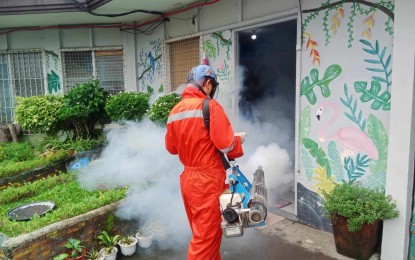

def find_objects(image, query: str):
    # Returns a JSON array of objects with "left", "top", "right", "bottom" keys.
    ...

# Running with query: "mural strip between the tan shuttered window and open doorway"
[{"left": 202, "top": 30, "right": 236, "bottom": 116}]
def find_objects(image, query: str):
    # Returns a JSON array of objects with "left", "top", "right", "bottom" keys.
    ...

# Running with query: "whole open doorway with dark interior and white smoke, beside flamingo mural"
[{"left": 237, "top": 20, "right": 297, "bottom": 214}]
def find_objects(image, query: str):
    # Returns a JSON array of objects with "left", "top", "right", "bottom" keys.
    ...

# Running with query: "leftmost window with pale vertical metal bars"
[{"left": 0, "top": 50, "right": 45, "bottom": 123}]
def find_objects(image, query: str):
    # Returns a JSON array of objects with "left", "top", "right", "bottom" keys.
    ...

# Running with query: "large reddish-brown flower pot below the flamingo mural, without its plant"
[{"left": 332, "top": 215, "right": 381, "bottom": 259}]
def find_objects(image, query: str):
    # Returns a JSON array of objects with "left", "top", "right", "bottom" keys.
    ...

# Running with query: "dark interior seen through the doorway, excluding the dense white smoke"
[{"left": 238, "top": 20, "right": 297, "bottom": 213}]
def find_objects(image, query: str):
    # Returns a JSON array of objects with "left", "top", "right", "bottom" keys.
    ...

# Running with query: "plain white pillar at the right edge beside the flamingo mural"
[{"left": 381, "top": 0, "right": 415, "bottom": 260}]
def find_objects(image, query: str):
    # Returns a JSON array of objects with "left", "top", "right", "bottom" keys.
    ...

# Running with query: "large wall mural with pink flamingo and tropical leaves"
[{"left": 297, "top": 0, "right": 394, "bottom": 231}]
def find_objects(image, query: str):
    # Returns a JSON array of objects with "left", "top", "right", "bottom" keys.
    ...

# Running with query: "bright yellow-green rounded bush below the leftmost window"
[{"left": 15, "top": 95, "right": 63, "bottom": 133}]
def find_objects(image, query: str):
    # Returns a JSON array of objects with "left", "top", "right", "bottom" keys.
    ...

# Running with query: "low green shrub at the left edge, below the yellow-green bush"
[{"left": 0, "top": 142, "right": 35, "bottom": 162}]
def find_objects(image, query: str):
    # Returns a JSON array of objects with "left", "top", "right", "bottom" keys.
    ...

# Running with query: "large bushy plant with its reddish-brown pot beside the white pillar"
[{"left": 323, "top": 183, "right": 399, "bottom": 259}]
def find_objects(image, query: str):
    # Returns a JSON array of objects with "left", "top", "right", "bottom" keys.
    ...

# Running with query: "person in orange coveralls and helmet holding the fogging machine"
[{"left": 165, "top": 65, "right": 246, "bottom": 260}]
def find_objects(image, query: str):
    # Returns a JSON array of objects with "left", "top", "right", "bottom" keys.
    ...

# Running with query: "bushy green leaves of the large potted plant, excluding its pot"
[{"left": 323, "top": 183, "right": 399, "bottom": 232}]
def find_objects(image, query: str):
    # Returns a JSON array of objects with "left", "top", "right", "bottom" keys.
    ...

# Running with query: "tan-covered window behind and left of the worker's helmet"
[{"left": 169, "top": 37, "right": 200, "bottom": 91}]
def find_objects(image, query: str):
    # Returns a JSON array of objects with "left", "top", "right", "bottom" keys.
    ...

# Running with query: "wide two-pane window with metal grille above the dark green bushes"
[{"left": 62, "top": 50, "right": 124, "bottom": 94}]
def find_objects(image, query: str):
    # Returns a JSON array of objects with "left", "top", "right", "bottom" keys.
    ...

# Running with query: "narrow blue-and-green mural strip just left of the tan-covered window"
[{"left": 137, "top": 37, "right": 164, "bottom": 94}]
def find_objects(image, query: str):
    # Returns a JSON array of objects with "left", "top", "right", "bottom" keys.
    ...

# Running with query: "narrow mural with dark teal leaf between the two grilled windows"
[{"left": 45, "top": 50, "right": 61, "bottom": 94}]
